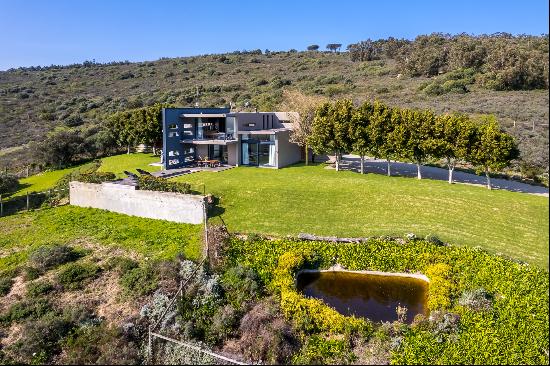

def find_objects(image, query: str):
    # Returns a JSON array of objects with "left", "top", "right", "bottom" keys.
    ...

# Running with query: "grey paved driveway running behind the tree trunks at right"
[{"left": 343, "top": 155, "right": 548, "bottom": 197}]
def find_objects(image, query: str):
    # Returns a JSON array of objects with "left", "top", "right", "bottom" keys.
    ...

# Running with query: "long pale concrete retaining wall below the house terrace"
[{"left": 69, "top": 182, "right": 205, "bottom": 224}]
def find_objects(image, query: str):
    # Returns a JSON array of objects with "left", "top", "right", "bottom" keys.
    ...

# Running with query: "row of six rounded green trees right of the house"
[{"left": 307, "top": 100, "right": 519, "bottom": 189}]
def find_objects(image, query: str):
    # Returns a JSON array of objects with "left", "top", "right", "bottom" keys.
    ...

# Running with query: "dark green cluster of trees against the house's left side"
[{"left": 108, "top": 103, "right": 170, "bottom": 154}]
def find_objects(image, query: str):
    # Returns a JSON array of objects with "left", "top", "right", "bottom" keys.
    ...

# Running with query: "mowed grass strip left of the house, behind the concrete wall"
[{"left": 9, "top": 153, "right": 160, "bottom": 196}]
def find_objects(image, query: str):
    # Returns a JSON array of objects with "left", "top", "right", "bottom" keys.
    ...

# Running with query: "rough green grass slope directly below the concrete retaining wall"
[{"left": 0, "top": 206, "right": 203, "bottom": 272}]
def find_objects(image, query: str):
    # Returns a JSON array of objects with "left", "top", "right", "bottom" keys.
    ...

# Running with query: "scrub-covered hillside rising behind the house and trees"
[{"left": 0, "top": 36, "right": 549, "bottom": 171}]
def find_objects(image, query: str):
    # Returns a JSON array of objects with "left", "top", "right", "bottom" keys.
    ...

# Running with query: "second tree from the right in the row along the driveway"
[{"left": 428, "top": 113, "right": 476, "bottom": 184}]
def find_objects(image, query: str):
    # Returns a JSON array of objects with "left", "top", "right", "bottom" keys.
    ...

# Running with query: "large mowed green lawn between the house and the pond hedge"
[{"left": 175, "top": 165, "right": 548, "bottom": 268}]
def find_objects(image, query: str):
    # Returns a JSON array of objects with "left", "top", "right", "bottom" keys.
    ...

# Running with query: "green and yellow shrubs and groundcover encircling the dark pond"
[{"left": 227, "top": 238, "right": 549, "bottom": 364}]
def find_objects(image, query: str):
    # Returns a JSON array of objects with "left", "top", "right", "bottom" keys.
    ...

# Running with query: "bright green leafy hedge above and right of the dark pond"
[{"left": 227, "top": 238, "right": 549, "bottom": 364}]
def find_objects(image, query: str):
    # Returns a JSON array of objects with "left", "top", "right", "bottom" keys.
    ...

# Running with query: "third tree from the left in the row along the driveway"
[{"left": 368, "top": 101, "right": 400, "bottom": 176}]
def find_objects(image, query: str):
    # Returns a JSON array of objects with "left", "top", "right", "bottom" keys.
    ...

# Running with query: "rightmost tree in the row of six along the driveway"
[{"left": 468, "top": 115, "right": 519, "bottom": 189}]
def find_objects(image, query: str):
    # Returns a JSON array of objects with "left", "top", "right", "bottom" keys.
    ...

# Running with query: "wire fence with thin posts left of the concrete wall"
[{"left": 0, "top": 188, "right": 69, "bottom": 217}]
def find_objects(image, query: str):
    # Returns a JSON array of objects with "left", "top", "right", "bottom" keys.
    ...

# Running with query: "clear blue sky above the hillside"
[{"left": 0, "top": 0, "right": 549, "bottom": 70}]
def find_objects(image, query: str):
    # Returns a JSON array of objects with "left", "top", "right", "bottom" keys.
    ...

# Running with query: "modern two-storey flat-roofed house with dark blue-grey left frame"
[{"left": 162, "top": 108, "right": 301, "bottom": 169}]
